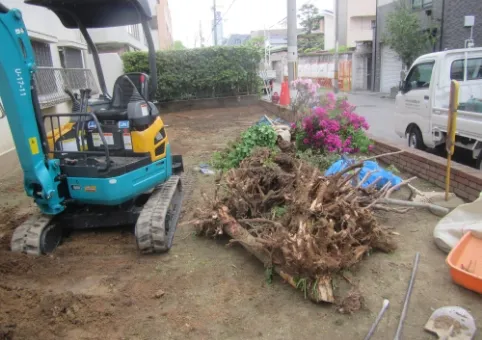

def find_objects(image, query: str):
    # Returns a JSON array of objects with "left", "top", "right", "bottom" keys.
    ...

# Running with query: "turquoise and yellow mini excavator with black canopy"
[{"left": 0, "top": 0, "right": 184, "bottom": 255}]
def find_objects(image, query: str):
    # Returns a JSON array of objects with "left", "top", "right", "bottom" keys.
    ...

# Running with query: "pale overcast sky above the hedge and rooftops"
[{"left": 169, "top": 0, "right": 333, "bottom": 47}]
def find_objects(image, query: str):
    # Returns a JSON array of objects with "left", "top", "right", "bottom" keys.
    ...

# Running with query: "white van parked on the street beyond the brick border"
[{"left": 394, "top": 48, "right": 482, "bottom": 169}]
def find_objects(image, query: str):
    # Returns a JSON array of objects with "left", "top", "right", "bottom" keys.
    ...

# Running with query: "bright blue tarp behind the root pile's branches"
[{"left": 325, "top": 156, "right": 402, "bottom": 189}]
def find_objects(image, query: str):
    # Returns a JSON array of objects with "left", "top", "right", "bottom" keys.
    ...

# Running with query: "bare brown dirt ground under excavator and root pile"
[{"left": 0, "top": 106, "right": 482, "bottom": 340}]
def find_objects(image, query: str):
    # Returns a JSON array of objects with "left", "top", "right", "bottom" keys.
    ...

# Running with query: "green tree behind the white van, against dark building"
[{"left": 383, "top": 1, "right": 434, "bottom": 68}]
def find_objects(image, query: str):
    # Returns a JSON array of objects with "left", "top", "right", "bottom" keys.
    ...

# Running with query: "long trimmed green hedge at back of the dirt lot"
[{"left": 122, "top": 46, "right": 261, "bottom": 102}]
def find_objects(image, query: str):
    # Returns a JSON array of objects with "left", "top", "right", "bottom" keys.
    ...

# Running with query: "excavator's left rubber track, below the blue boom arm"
[{"left": 10, "top": 213, "right": 62, "bottom": 255}]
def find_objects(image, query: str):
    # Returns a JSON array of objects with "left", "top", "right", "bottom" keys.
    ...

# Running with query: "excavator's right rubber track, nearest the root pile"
[{"left": 135, "top": 176, "right": 183, "bottom": 253}]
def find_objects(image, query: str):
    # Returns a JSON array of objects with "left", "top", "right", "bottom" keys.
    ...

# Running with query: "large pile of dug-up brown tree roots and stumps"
[{"left": 194, "top": 149, "right": 404, "bottom": 302}]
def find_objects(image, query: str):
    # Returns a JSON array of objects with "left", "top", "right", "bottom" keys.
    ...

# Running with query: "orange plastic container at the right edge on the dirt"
[{"left": 447, "top": 232, "right": 482, "bottom": 294}]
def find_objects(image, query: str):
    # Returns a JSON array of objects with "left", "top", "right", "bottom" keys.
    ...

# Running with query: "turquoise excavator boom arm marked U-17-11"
[{"left": 0, "top": 3, "right": 64, "bottom": 215}]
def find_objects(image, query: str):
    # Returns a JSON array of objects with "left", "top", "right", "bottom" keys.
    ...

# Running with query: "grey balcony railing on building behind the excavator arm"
[{"left": 35, "top": 67, "right": 99, "bottom": 109}]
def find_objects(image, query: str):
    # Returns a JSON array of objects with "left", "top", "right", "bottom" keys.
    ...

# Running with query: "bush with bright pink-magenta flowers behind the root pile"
[{"left": 292, "top": 93, "right": 371, "bottom": 154}]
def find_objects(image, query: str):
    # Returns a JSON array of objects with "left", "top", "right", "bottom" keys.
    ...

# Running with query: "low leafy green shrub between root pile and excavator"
[{"left": 211, "top": 125, "right": 278, "bottom": 170}]
